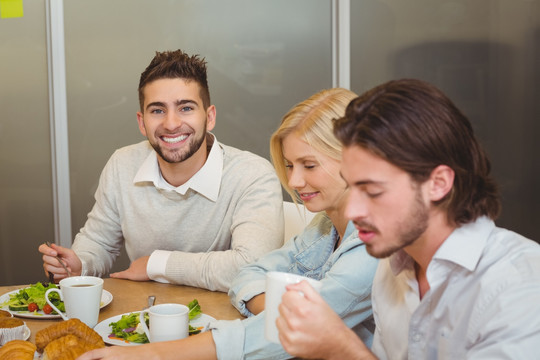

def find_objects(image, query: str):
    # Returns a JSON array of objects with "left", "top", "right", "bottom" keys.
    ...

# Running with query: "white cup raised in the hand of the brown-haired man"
[{"left": 264, "top": 271, "right": 322, "bottom": 344}]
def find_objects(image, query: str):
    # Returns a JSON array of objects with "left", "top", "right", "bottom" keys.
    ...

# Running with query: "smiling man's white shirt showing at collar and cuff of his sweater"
[{"left": 133, "top": 135, "right": 223, "bottom": 283}]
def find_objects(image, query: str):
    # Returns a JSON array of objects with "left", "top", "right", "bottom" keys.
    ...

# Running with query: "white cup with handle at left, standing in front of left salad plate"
[{"left": 45, "top": 276, "right": 103, "bottom": 328}]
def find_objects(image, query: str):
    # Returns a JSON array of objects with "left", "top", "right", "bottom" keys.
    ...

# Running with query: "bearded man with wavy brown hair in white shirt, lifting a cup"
[{"left": 277, "top": 79, "right": 540, "bottom": 359}]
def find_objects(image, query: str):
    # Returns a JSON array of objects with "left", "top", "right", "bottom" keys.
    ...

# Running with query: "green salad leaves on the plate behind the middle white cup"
[{"left": 109, "top": 299, "right": 202, "bottom": 344}]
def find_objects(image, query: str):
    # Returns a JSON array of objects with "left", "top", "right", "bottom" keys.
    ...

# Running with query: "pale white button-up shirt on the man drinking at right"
[{"left": 372, "top": 217, "right": 540, "bottom": 360}]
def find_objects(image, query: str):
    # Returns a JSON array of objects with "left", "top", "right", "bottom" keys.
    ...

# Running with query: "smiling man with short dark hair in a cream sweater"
[{"left": 39, "top": 50, "right": 283, "bottom": 291}]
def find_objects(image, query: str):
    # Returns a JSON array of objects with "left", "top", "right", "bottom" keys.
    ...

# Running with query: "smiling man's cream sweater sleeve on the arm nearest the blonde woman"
[{"left": 165, "top": 155, "right": 283, "bottom": 292}]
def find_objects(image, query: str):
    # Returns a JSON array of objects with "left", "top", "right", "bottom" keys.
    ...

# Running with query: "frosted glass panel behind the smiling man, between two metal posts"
[{"left": 64, "top": 0, "right": 332, "bottom": 267}]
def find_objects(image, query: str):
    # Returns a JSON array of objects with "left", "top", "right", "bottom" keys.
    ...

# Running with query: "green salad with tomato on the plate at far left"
[{"left": 0, "top": 282, "right": 65, "bottom": 314}]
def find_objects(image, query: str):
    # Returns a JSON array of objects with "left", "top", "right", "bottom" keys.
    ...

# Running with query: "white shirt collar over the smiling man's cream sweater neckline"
[{"left": 133, "top": 133, "right": 223, "bottom": 202}]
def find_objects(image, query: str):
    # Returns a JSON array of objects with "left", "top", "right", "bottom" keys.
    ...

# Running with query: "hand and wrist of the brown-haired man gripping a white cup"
[{"left": 276, "top": 281, "right": 375, "bottom": 359}]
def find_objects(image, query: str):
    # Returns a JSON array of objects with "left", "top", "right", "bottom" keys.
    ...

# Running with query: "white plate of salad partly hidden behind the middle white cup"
[{"left": 94, "top": 299, "right": 215, "bottom": 346}]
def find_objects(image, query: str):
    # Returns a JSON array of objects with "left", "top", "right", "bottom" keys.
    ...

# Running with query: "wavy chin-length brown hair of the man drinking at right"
[{"left": 334, "top": 79, "right": 501, "bottom": 225}]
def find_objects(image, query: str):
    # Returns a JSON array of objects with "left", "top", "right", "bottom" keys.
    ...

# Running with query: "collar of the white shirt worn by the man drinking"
[{"left": 390, "top": 216, "right": 495, "bottom": 275}]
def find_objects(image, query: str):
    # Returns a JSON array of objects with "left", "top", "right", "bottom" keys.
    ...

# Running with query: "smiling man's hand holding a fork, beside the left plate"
[{"left": 38, "top": 244, "right": 82, "bottom": 282}]
